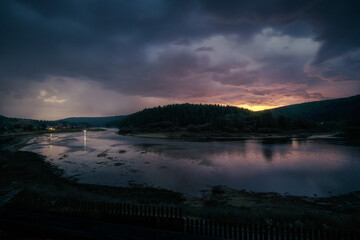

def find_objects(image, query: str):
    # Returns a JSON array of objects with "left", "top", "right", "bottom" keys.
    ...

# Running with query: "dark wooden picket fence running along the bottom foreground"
[{"left": 12, "top": 199, "right": 360, "bottom": 240}]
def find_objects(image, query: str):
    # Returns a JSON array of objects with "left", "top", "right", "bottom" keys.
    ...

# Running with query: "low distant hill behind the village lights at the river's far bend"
[{"left": 62, "top": 116, "right": 125, "bottom": 127}]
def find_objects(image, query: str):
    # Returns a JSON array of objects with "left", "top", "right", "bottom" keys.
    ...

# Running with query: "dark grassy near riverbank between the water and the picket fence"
[{"left": 0, "top": 131, "right": 360, "bottom": 231}]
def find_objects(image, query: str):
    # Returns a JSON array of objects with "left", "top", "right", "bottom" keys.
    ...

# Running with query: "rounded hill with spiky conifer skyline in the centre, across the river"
[{"left": 119, "top": 103, "right": 315, "bottom": 133}]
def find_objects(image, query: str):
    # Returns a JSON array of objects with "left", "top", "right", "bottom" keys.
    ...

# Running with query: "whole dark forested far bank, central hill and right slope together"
[{"left": 119, "top": 95, "right": 360, "bottom": 137}]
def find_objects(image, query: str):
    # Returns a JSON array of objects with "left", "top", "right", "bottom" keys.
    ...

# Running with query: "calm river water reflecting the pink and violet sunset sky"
[{"left": 22, "top": 130, "right": 360, "bottom": 196}]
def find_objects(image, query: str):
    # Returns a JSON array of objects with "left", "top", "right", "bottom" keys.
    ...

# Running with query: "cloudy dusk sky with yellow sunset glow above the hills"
[{"left": 0, "top": 0, "right": 360, "bottom": 120}]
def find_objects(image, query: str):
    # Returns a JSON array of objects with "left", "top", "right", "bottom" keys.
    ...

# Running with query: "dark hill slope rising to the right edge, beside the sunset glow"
[{"left": 271, "top": 95, "right": 360, "bottom": 122}]
